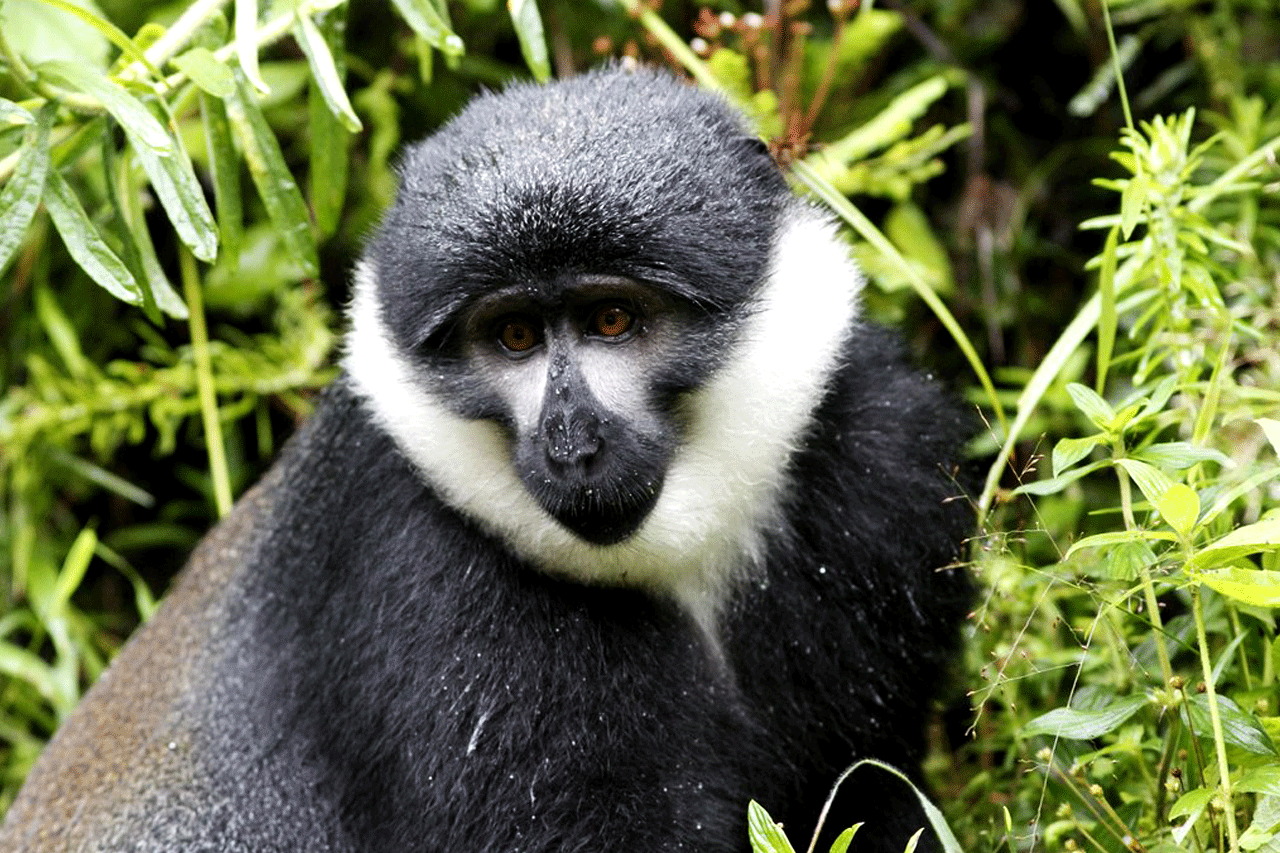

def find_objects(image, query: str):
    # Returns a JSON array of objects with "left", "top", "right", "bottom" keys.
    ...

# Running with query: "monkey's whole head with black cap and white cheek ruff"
[{"left": 346, "top": 70, "right": 859, "bottom": 604}]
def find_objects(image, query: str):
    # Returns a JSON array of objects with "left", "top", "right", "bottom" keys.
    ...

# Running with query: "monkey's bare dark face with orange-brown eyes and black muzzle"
[{"left": 439, "top": 275, "right": 705, "bottom": 544}]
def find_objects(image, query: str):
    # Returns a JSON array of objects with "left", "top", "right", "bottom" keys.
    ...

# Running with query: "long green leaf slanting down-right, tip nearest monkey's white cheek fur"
[{"left": 227, "top": 73, "right": 319, "bottom": 275}]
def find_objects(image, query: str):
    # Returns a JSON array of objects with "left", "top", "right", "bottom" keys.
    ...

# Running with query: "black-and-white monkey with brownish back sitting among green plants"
[{"left": 0, "top": 68, "right": 973, "bottom": 853}]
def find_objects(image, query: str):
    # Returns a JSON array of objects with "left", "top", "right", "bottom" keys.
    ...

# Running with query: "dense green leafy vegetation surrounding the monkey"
[{"left": 0, "top": 0, "right": 1280, "bottom": 853}]
